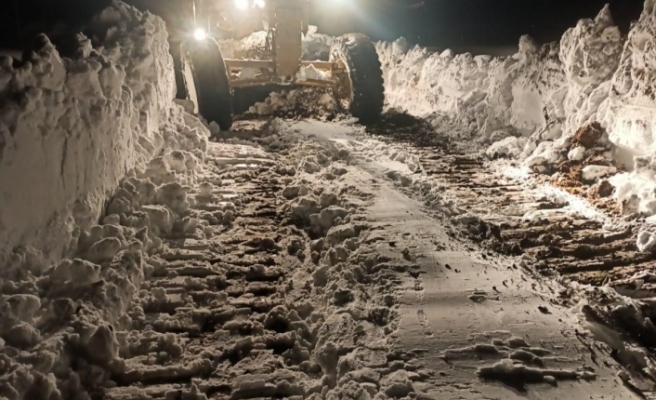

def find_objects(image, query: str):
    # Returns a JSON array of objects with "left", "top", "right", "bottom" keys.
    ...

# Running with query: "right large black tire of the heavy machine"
[{"left": 330, "top": 33, "right": 385, "bottom": 124}]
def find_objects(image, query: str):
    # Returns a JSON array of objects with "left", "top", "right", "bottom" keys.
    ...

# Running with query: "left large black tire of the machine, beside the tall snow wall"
[{"left": 188, "top": 38, "right": 232, "bottom": 131}]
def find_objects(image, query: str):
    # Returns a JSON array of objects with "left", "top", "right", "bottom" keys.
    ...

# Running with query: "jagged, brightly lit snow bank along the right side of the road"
[{"left": 377, "top": 0, "right": 656, "bottom": 225}]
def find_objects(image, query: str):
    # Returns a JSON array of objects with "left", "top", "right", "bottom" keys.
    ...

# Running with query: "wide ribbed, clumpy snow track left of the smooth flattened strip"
[{"left": 99, "top": 125, "right": 426, "bottom": 399}]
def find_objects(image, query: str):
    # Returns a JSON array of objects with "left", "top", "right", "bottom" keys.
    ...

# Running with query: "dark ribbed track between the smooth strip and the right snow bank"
[{"left": 356, "top": 113, "right": 656, "bottom": 394}]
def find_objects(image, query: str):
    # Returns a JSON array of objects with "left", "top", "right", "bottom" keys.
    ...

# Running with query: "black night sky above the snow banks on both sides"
[{"left": 0, "top": 0, "right": 644, "bottom": 50}]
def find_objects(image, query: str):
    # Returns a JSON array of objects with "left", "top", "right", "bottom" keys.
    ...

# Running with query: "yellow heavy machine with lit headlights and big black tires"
[{"left": 165, "top": 0, "right": 384, "bottom": 130}]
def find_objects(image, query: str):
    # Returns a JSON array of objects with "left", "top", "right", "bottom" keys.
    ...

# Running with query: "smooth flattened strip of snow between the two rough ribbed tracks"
[{"left": 250, "top": 121, "right": 638, "bottom": 399}]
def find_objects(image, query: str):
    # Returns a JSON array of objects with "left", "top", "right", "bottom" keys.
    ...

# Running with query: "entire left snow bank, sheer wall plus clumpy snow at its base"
[{"left": 0, "top": 2, "right": 214, "bottom": 400}]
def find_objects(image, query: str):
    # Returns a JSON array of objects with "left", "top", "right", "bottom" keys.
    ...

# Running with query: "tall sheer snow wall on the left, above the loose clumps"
[{"left": 0, "top": 2, "right": 175, "bottom": 272}]
